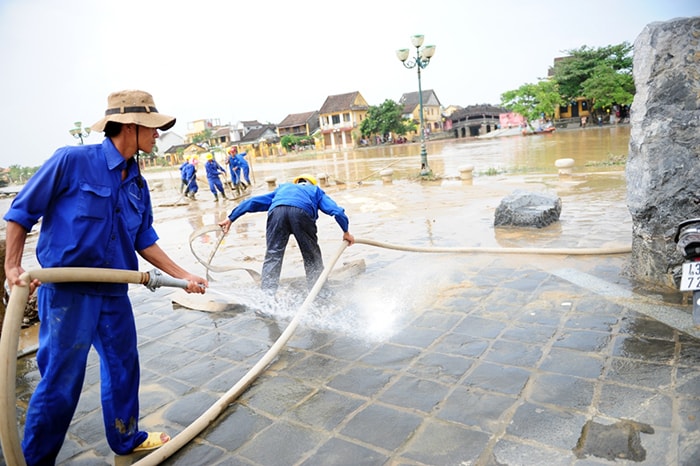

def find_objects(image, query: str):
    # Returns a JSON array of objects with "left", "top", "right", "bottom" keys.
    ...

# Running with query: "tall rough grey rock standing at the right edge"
[{"left": 626, "top": 17, "right": 700, "bottom": 288}]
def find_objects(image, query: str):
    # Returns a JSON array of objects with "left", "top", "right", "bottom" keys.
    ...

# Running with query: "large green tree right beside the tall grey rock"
[{"left": 552, "top": 42, "right": 635, "bottom": 109}]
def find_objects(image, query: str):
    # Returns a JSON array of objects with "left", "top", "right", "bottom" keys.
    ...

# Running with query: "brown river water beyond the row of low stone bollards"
[{"left": 223, "top": 126, "right": 629, "bottom": 183}]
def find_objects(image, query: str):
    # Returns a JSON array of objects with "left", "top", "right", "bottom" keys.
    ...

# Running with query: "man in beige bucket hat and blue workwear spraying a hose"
[{"left": 4, "top": 91, "right": 208, "bottom": 466}]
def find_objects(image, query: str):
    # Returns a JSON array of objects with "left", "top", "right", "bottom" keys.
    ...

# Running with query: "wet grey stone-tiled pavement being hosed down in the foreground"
[{"left": 1, "top": 173, "right": 700, "bottom": 466}]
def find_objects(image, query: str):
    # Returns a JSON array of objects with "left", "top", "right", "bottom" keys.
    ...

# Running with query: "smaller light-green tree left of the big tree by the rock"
[{"left": 501, "top": 79, "right": 563, "bottom": 127}]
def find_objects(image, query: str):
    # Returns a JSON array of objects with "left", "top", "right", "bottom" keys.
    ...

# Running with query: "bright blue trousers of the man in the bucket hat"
[{"left": 22, "top": 286, "right": 148, "bottom": 466}]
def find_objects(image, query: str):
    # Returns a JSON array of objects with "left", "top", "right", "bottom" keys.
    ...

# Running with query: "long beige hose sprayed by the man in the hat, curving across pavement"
[{"left": 0, "top": 238, "right": 631, "bottom": 466}]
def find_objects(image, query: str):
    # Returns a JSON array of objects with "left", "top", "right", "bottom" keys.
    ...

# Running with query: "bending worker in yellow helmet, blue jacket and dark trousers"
[{"left": 219, "top": 174, "right": 355, "bottom": 294}]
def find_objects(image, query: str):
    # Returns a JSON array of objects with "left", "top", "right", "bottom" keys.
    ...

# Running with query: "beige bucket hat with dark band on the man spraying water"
[{"left": 90, "top": 90, "right": 175, "bottom": 131}]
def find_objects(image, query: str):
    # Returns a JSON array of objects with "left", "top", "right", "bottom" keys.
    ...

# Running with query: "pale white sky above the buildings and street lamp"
[{"left": 0, "top": 0, "right": 700, "bottom": 167}]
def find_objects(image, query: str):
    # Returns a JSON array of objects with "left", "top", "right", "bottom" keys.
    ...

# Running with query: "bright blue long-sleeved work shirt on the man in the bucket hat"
[{"left": 4, "top": 138, "right": 158, "bottom": 296}]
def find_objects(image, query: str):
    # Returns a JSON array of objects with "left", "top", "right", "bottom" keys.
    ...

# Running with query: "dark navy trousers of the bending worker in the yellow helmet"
[{"left": 262, "top": 205, "right": 323, "bottom": 293}]
